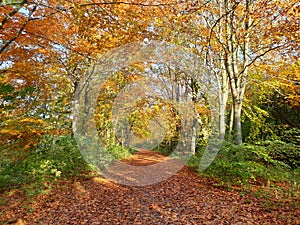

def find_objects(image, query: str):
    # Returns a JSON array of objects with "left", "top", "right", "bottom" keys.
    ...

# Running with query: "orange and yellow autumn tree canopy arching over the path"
[{"left": 0, "top": 0, "right": 300, "bottom": 149}]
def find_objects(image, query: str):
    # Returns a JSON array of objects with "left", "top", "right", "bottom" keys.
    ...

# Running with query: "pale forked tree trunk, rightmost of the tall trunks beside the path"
[{"left": 224, "top": 0, "right": 251, "bottom": 144}]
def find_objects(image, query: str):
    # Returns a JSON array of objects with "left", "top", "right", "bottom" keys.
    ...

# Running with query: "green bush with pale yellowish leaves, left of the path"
[{"left": 0, "top": 135, "right": 89, "bottom": 189}]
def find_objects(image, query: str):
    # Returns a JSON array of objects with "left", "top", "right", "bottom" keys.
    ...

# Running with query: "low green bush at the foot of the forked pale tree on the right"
[{"left": 188, "top": 142, "right": 293, "bottom": 184}]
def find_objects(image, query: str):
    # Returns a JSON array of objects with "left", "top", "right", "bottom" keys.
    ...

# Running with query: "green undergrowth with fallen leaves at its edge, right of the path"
[{"left": 188, "top": 141, "right": 300, "bottom": 209}]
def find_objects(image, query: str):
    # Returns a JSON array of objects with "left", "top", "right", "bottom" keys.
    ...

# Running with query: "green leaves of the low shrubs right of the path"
[{"left": 193, "top": 142, "right": 300, "bottom": 185}]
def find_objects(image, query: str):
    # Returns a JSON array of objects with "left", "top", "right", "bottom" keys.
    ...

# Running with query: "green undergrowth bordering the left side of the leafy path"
[{"left": 0, "top": 135, "right": 134, "bottom": 195}]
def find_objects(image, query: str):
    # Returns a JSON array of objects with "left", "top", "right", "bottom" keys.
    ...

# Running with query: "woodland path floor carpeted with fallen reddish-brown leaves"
[{"left": 0, "top": 151, "right": 300, "bottom": 225}]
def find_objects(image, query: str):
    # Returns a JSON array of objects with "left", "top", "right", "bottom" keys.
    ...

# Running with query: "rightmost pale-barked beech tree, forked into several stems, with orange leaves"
[{"left": 212, "top": 0, "right": 299, "bottom": 144}]
